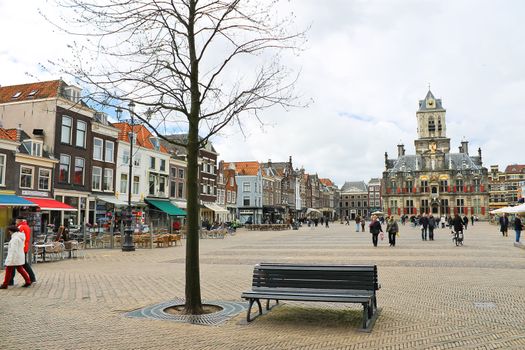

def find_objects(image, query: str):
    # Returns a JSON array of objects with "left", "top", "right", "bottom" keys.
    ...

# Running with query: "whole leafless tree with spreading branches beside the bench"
[{"left": 51, "top": 0, "right": 304, "bottom": 314}]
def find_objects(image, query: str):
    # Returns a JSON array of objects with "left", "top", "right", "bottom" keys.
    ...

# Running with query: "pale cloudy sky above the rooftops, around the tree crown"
[{"left": 0, "top": 0, "right": 525, "bottom": 186}]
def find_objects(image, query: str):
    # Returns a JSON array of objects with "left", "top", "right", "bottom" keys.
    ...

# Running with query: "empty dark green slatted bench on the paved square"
[{"left": 241, "top": 263, "right": 381, "bottom": 330}]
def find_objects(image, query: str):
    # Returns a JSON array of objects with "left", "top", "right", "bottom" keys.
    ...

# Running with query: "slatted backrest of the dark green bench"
[{"left": 252, "top": 263, "right": 379, "bottom": 291}]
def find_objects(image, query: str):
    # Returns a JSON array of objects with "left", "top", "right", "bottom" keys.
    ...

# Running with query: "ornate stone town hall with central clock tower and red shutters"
[{"left": 381, "top": 90, "right": 488, "bottom": 218}]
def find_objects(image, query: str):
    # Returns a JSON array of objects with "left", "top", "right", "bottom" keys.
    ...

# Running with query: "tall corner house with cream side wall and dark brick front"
[{"left": 0, "top": 80, "right": 94, "bottom": 225}]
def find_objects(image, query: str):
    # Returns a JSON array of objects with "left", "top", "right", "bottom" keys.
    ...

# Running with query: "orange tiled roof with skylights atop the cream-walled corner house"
[{"left": 0, "top": 80, "right": 63, "bottom": 103}]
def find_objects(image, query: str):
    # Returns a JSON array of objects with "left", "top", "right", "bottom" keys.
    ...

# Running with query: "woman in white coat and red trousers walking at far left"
[{"left": 0, "top": 225, "right": 31, "bottom": 289}]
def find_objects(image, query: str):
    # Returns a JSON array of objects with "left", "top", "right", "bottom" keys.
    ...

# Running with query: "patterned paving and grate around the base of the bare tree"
[{"left": 125, "top": 299, "right": 248, "bottom": 326}]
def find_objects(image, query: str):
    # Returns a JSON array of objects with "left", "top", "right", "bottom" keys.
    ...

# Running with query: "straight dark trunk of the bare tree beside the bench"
[{"left": 185, "top": 0, "right": 203, "bottom": 315}]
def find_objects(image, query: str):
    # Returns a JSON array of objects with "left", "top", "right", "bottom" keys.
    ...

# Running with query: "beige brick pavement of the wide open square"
[{"left": 0, "top": 223, "right": 525, "bottom": 349}]
